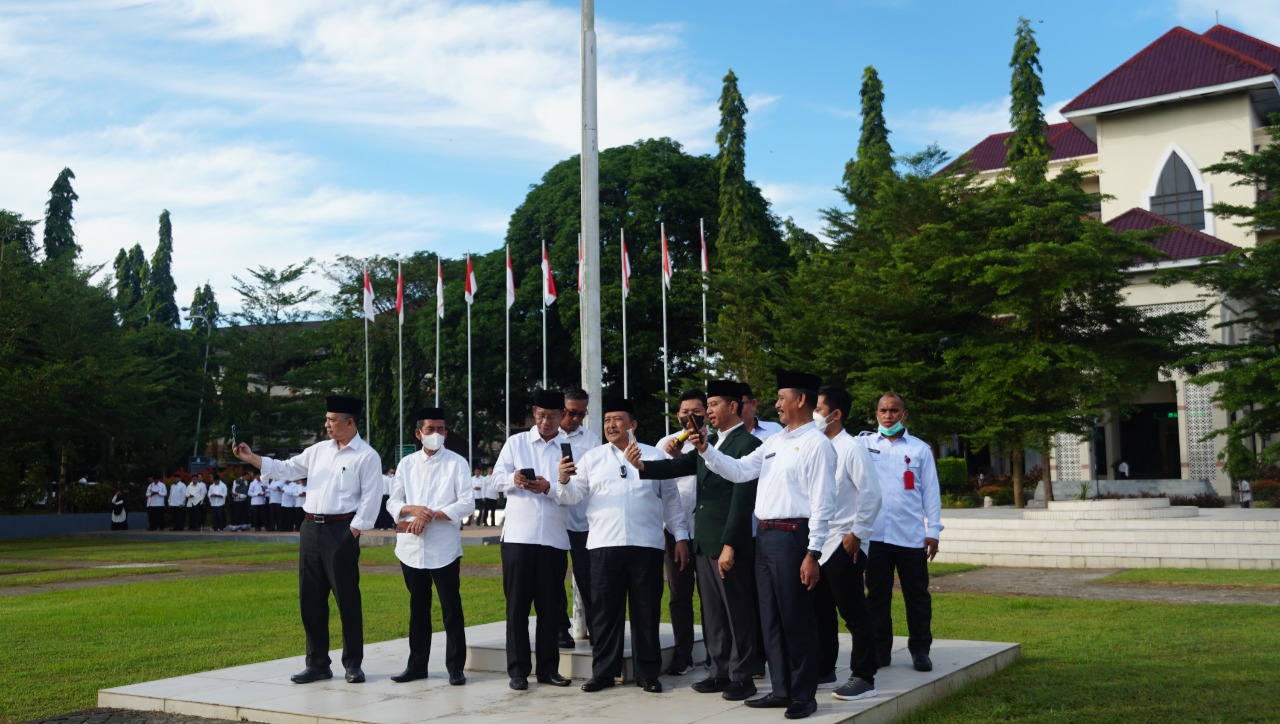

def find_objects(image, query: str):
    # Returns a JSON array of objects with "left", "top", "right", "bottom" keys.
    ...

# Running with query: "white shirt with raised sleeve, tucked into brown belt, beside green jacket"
[{"left": 703, "top": 422, "right": 836, "bottom": 550}]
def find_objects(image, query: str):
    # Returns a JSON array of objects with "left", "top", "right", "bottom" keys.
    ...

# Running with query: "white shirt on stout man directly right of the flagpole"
[{"left": 553, "top": 444, "right": 689, "bottom": 550}]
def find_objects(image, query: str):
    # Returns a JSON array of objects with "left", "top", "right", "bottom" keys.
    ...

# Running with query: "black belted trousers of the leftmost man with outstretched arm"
[{"left": 298, "top": 521, "right": 365, "bottom": 669}]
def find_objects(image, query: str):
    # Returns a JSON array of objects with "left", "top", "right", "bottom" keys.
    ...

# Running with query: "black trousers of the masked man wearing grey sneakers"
[{"left": 813, "top": 545, "right": 877, "bottom": 684}]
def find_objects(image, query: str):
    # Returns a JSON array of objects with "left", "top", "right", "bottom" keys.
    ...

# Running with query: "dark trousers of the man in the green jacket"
[{"left": 694, "top": 555, "right": 759, "bottom": 682}]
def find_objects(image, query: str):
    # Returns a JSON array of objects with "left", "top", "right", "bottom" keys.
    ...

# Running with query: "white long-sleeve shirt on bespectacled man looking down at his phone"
[{"left": 489, "top": 427, "right": 568, "bottom": 550}]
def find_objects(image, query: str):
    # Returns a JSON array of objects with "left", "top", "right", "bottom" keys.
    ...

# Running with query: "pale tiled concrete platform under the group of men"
[{"left": 97, "top": 622, "right": 1020, "bottom": 724}]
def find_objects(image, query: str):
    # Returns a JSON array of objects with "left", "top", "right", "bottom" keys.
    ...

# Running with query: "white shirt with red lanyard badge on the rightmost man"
[{"left": 856, "top": 432, "right": 942, "bottom": 547}]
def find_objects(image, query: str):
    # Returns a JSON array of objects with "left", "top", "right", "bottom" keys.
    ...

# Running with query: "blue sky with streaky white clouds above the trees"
[{"left": 0, "top": 0, "right": 1280, "bottom": 317}]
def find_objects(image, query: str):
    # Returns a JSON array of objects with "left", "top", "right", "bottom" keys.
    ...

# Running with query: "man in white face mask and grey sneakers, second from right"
[{"left": 813, "top": 386, "right": 881, "bottom": 701}]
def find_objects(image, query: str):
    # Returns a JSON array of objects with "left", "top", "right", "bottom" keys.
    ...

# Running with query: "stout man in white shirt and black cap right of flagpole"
[{"left": 556, "top": 398, "right": 689, "bottom": 693}]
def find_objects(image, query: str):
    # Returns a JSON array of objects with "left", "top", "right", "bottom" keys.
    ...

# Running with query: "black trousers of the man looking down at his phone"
[{"left": 502, "top": 542, "right": 567, "bottom": 677}]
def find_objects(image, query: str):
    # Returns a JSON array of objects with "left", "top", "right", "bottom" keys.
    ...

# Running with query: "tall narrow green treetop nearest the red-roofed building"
[{"left": 1005, "top": 18, "right": 1050, "bottom": 180}]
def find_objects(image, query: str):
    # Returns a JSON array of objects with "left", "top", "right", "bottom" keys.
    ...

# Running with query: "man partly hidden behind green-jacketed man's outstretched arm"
[{"left": 654, "top": 390, "right": 707, "bottom": 677}]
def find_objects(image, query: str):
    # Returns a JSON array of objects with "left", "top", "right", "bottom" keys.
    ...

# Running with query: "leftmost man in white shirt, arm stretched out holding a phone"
[{"left": 236, "top": 397, "right": 383, "bottom": 684}]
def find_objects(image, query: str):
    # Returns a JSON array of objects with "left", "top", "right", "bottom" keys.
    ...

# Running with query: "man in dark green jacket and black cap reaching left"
[{"left": 627, "top": 380, "right": 760, "bottom": 701}]
